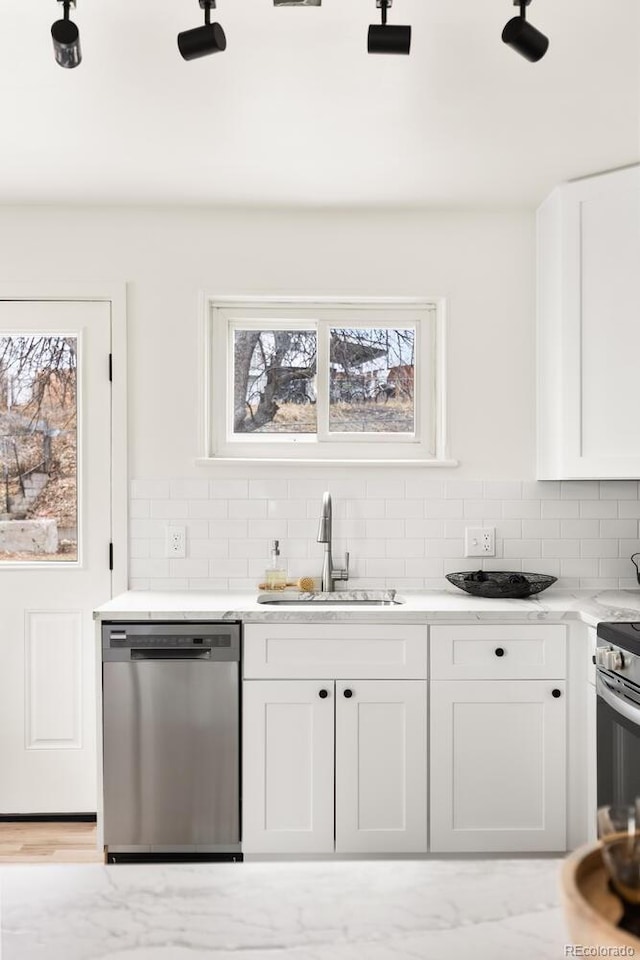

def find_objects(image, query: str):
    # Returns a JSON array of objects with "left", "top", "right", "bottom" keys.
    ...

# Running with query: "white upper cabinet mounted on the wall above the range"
[{"left": 537, "top": 166, "right": 640, "bottom": 480}]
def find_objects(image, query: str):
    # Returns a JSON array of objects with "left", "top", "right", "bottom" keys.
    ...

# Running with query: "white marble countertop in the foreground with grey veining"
[{"left": 0, "top": 859, "right": 570, "bottom": 960}]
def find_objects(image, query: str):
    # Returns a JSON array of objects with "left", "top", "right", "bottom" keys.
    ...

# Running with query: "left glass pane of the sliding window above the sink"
[{"left": 233, "top": 330, "right": 317, "bottom": 435}]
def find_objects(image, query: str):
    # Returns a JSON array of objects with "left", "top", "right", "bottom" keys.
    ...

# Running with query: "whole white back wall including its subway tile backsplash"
[{"left": 0, "top": 205, "right": 640, "bottom": 589}]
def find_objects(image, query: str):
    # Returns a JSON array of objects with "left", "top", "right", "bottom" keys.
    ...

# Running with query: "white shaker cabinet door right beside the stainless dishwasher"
[{"left": 242, "top": 680, "right": 334, "bottom": 853}]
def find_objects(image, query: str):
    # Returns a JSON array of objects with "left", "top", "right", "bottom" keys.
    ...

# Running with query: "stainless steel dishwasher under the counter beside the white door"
[{"left": 102, "top": 622, "right": 242, "bottom": 863}]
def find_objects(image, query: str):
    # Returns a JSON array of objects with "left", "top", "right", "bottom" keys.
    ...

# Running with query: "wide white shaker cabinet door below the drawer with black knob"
[{"left": 430, "top": 680, "right": 566, "bottom": 853}]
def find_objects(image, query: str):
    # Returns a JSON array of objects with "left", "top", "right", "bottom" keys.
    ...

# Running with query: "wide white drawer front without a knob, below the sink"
[{"left": 244, "top": 623, "right": 427, "bottom": 680}]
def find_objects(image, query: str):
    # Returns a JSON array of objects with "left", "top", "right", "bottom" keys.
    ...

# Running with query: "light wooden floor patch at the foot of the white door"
[{"left": 0, "top": 821, "right": 104, "bottom": 864}]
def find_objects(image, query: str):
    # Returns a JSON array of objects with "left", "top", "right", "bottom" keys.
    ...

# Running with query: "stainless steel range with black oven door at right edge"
[{"left": 595, "top": 623, "right": 640, "bottom": 806}]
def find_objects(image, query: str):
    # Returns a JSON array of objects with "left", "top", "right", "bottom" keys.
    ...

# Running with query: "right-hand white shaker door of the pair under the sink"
[{"left": 336, "top": 680, "right": 427, "bottom": 853}]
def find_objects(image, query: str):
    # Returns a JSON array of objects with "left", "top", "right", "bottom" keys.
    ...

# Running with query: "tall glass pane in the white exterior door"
[{"left": 0, "top": 336, "right": 78, "bottom": 563}]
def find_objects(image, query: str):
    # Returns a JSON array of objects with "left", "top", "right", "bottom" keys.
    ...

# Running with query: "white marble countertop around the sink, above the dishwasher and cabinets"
[{"left": 94, "top": 587, "right": 640, "bottom": 626}]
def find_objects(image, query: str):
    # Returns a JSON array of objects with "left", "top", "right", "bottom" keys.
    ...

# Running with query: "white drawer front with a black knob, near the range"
[{"left": 430, "top": 624, "right": 566, "bottom": 680}]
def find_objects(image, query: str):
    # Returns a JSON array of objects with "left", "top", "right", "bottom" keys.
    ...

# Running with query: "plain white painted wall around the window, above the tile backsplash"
[{"left": 0, "top": 207, "right": 535, "bottom": 480}]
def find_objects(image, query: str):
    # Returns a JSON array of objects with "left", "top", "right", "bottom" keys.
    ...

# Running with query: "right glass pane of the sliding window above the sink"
[{"left": 329, "top": 327, "right": 415, "bottom": 433}]
